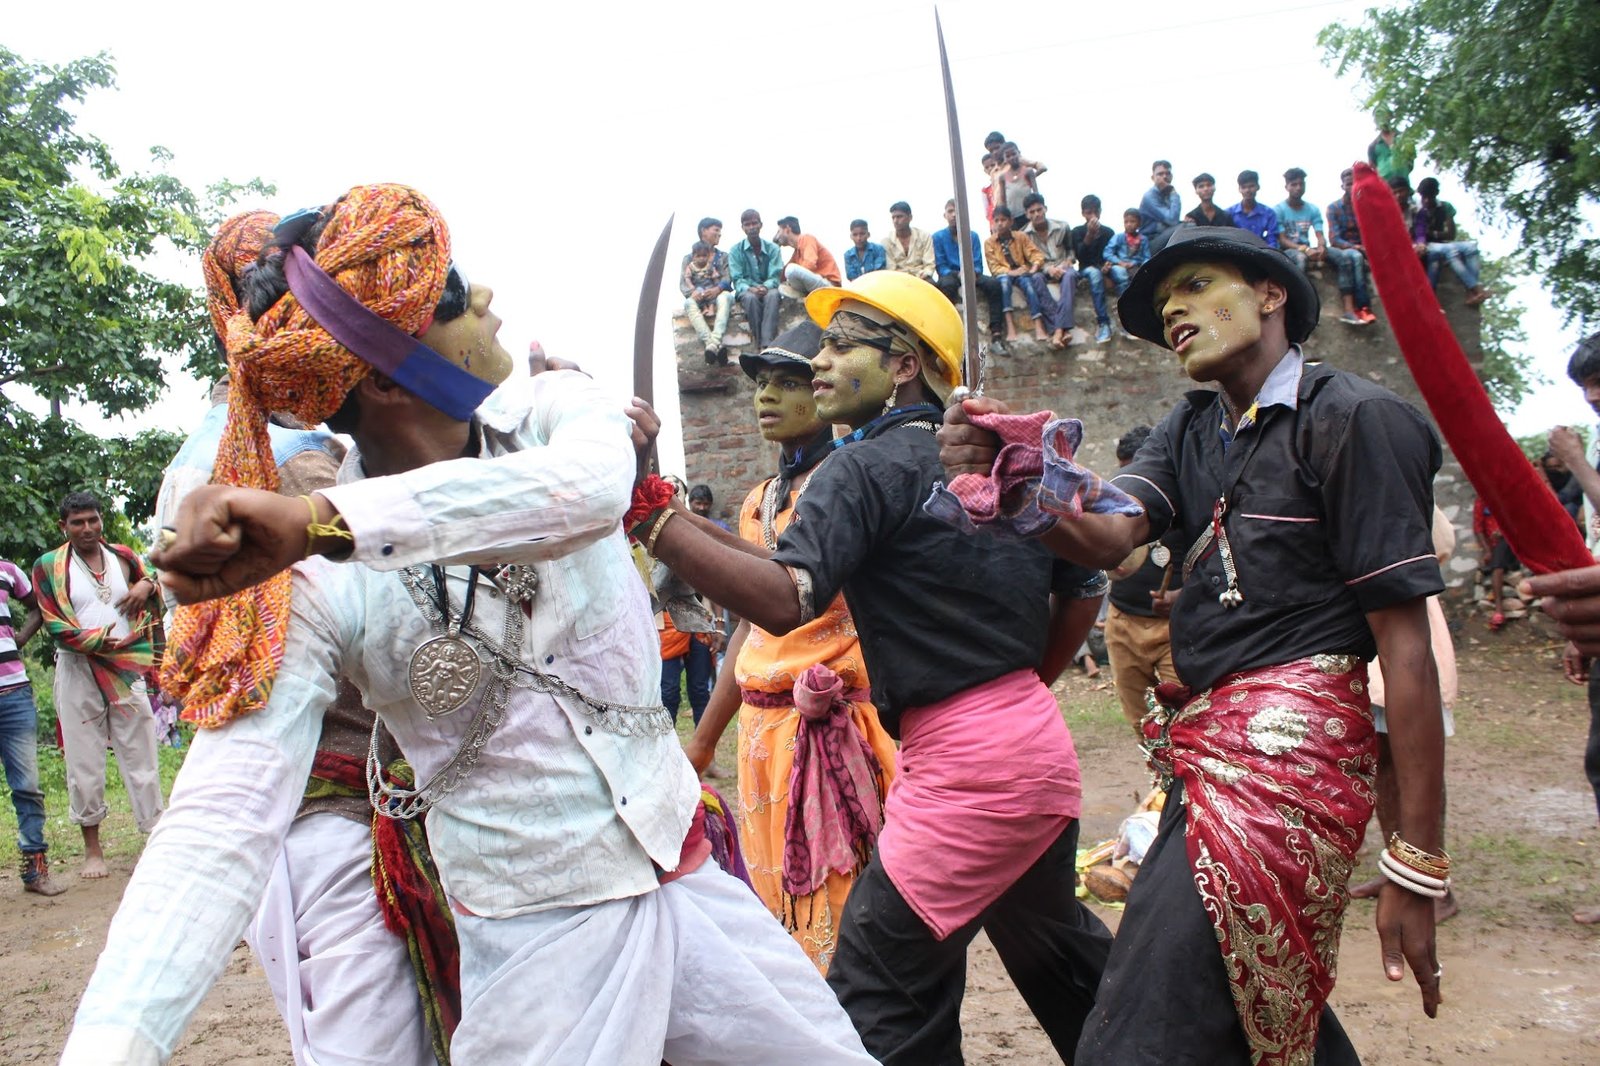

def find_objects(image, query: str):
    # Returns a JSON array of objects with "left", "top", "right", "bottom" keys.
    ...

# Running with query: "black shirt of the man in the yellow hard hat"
[{"left": 773, "top": 408, "right": 1106, "bottom": 736}]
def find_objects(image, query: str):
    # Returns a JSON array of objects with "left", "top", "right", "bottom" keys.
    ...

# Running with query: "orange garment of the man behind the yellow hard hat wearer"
[{"left": 734, "top": 482, "right": 896, "bottom": 975}]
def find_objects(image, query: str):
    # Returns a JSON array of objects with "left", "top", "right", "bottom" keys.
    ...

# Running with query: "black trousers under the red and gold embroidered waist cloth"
[{"left": 1078, "top": 784, "right": 1362, "bottom": 1066}]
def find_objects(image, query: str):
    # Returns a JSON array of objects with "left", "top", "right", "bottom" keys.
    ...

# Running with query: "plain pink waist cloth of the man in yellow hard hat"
[{"left": 878, "top": 671, "right": 1082, "bottom": 940}]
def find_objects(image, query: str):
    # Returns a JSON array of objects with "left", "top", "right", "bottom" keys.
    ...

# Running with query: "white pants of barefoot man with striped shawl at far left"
[{"left": 54, "top": 651, "right": 162, "bottom": 832}]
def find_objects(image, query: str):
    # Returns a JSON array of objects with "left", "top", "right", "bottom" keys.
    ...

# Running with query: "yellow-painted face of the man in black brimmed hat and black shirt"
[{"left": 1155, "top": 261, "right": 1262, "bottom": 381}]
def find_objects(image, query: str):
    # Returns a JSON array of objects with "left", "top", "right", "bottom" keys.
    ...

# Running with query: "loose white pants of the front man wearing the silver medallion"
[{"left": 450, "top": 861, "right": 874, "bottom": 1066}]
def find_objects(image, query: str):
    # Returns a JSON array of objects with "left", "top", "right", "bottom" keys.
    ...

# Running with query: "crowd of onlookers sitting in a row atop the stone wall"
[{"left": 680, "top": 130, "right": 1490, "bottom": 363}]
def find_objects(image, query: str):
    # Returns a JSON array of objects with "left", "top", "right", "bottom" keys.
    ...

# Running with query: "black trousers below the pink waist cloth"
[{"left": 827, "top": 821, "right": 1113, "bottom": 1066}]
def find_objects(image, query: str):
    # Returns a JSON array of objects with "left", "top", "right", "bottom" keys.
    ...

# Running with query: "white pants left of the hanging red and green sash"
[{"left": 245, "top": 813, "right": 435, "bottom": 1066}]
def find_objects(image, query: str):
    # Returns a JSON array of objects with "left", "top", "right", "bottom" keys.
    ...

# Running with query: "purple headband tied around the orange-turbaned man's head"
[{"left": 283, "top": 245, "right": 494, "bottom": 423}]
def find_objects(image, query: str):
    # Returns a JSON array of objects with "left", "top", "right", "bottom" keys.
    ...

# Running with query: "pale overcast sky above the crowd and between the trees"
[{"left": 3, "top": 0, "right": 1594, "bottom": 469}]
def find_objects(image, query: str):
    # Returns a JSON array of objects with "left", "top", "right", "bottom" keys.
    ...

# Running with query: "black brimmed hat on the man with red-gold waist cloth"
[{"left": 1117, "top": 226, "right": 1322, "bottom": 347}]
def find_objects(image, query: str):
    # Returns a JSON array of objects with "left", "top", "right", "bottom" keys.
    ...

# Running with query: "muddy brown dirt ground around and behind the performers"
[{"left": 0, "top": 619, "right": 1600, "bottom": 1066}]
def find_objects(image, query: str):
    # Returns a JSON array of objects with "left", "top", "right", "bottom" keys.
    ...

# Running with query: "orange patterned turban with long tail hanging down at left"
[{"left": 162, "top": 184, "right": 450, "bottom": 728}]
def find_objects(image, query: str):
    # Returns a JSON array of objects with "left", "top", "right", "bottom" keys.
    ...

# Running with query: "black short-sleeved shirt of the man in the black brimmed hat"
[{"left": 1112, "top": 356, "right": 1445, "bottom": 691}]
